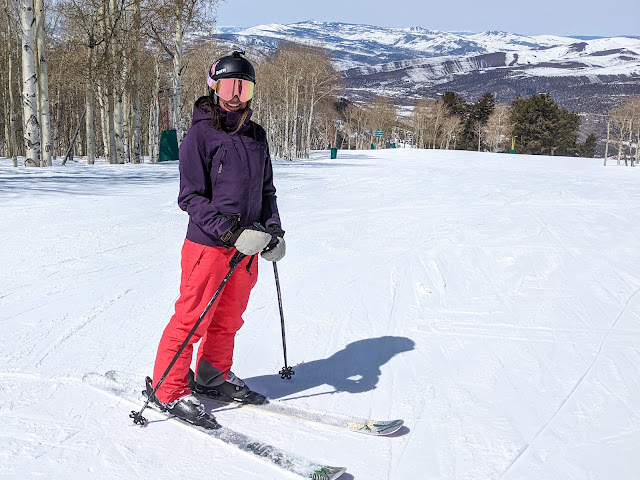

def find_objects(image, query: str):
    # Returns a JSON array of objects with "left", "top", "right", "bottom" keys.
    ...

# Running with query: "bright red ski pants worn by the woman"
[{"left": 153, "top": 240, "right": 258, "bottom": 403}]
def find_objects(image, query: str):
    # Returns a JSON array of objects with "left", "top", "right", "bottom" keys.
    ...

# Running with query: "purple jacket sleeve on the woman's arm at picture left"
[{"left": 178, "top": 132, "right": 239, "bottom": 237}]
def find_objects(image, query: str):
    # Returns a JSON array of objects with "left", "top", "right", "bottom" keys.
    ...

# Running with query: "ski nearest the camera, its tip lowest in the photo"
[{"left": 82, "top": 371, "right": 346, "bottom": 480}]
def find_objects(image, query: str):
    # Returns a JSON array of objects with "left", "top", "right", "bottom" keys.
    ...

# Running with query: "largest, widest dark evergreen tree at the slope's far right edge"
[{"left": 511, "top": 93, "right": 580, "bottom": 155}]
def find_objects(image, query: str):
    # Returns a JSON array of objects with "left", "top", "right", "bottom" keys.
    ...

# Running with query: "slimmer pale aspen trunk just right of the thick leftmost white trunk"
[{"left": 35, "top": 0, "right": 53, "bottom": 166}]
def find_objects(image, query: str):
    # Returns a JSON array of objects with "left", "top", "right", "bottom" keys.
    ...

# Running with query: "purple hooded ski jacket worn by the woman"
[{"left": 178, "top": 99, "right": 281, "bottom": 247}]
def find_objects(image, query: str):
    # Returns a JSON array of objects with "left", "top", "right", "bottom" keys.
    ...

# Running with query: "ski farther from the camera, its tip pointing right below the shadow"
[{"left": 189, "top": 371, "right": 404, "bottom": 436}]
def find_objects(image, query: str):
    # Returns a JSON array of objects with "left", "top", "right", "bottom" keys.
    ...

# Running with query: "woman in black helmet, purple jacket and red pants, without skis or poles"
[{"left": 147, "top": 52, "right": 285, "bottom": 428}]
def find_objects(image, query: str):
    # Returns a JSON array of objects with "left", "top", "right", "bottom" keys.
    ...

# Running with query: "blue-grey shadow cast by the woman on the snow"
[{"left": 245, "top": 336, "right": 415, "bottom": 399}]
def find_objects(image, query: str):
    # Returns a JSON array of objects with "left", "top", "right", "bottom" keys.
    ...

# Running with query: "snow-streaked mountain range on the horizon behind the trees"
[{"left": 209, "top": 21, "right": 640, "bottom": 111}]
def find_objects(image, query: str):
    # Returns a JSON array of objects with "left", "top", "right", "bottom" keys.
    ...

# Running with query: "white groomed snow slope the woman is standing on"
[{"left": 0, "top": 149, "right": 640, "bottom": 480}]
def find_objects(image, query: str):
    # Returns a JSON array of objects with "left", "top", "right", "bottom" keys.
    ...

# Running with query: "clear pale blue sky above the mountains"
[{"left": 218, "top": 0, "right": 640, "bottom": 36}]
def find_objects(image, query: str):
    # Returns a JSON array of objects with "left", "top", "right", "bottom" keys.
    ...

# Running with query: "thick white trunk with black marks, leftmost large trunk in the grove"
[{"left": 21, "top": 0, "right": 41, "bottom": 166}]
